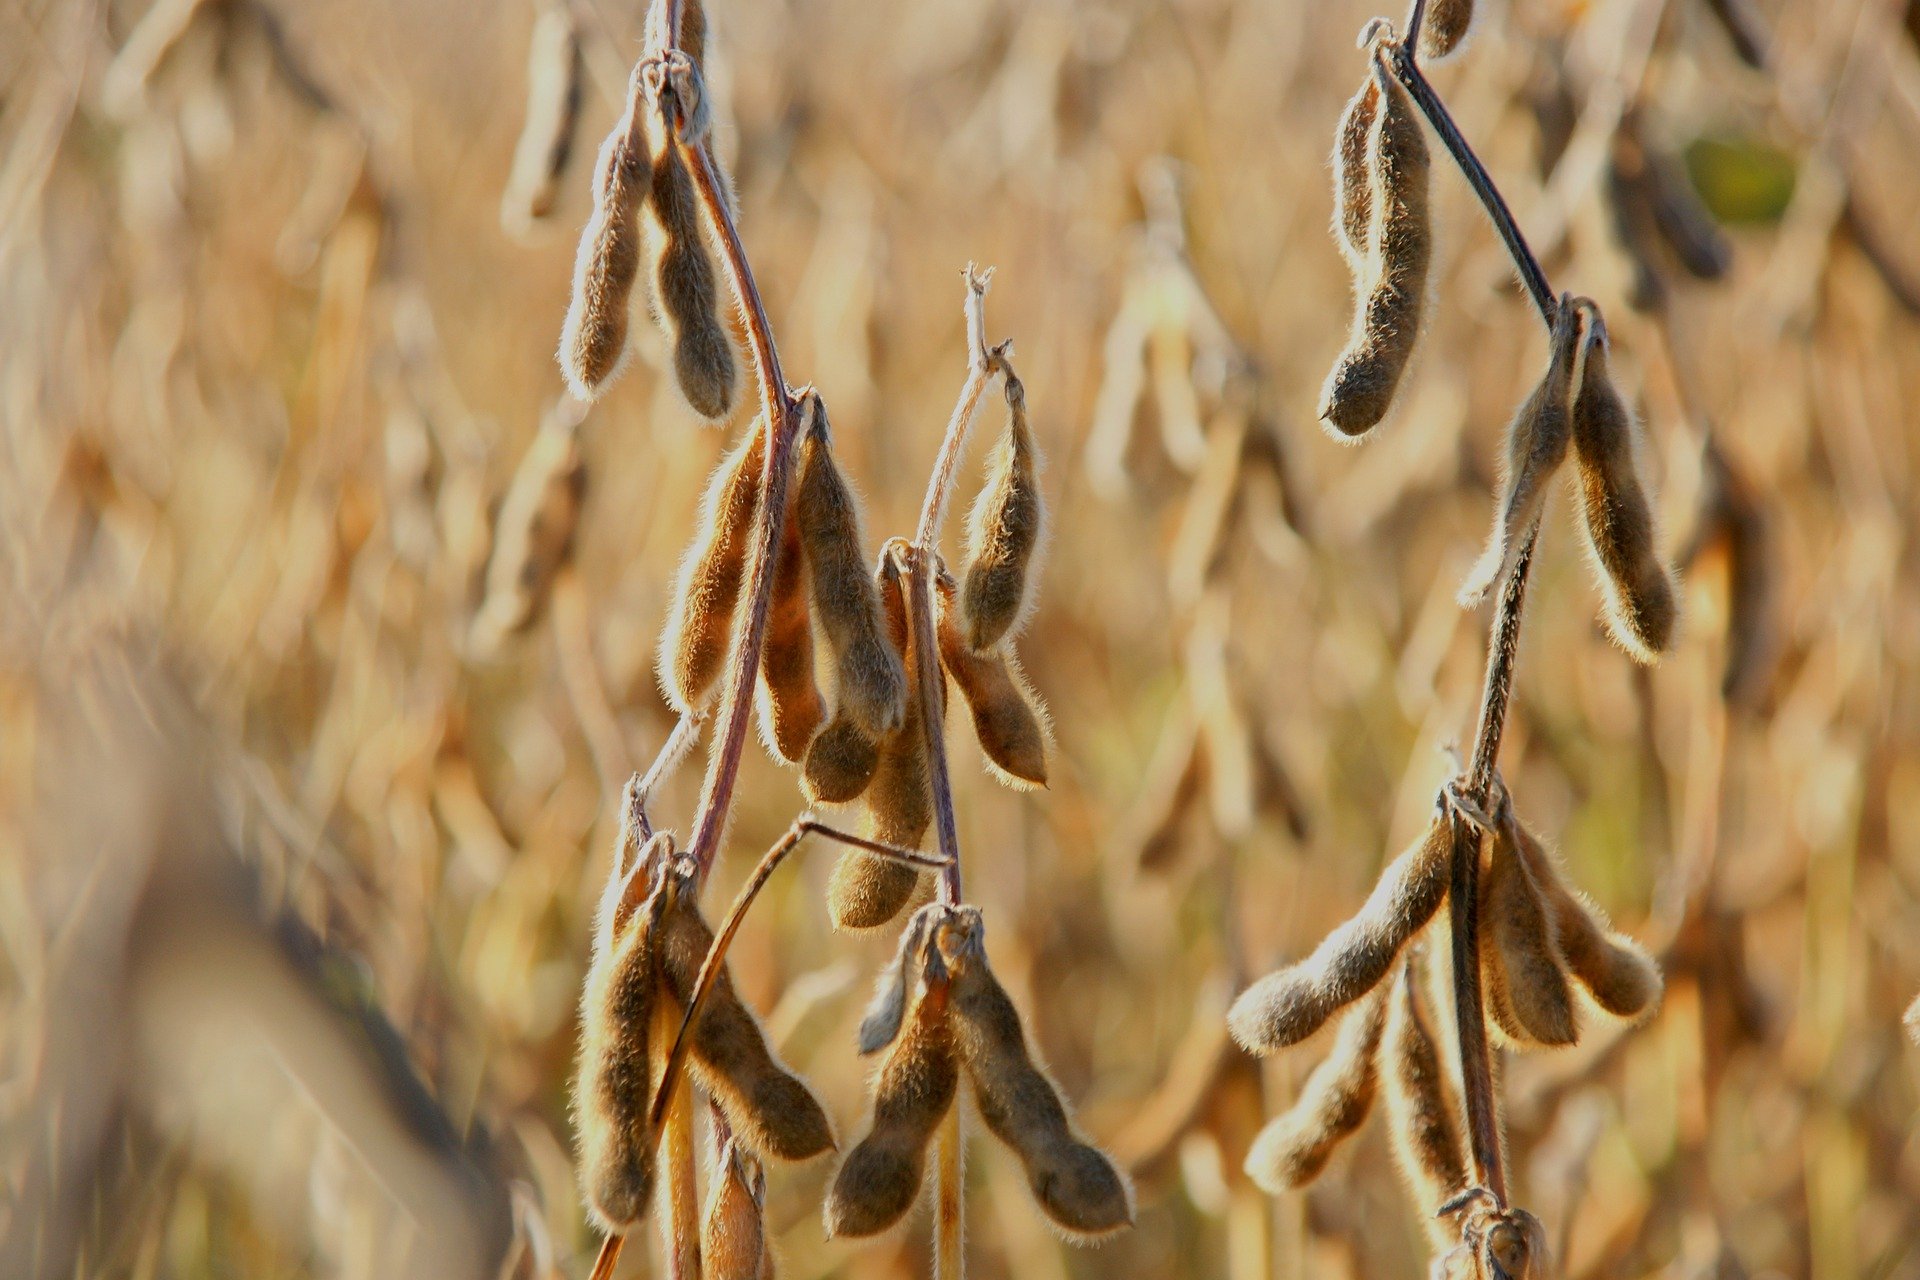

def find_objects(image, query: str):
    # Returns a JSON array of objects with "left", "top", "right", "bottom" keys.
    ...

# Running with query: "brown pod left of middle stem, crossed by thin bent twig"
[{"left": 828, "top": 555, "right": 933, "bottom": 929}]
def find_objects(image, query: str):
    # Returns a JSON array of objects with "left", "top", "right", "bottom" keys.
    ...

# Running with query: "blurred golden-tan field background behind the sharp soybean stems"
[{"left": 0, "top": 0, "right": 1920, "bottom": 1280}]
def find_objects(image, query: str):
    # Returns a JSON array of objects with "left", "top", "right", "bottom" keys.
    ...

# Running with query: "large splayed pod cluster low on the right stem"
[{"left": 1229, "top": 791, "right": 1661, "bottom": 1244}]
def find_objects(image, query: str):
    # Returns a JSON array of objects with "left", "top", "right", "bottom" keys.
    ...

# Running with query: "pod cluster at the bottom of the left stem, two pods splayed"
[{"left": 574, "top": 796, "right": 833, "bottom": 1232}]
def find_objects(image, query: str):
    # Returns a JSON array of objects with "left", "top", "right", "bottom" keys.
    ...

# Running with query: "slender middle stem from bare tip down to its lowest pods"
[{"left": 900, "top": 263, "right": 1006, "bottom": 906}]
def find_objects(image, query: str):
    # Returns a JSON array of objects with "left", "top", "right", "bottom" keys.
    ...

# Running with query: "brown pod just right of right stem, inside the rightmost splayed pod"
[{"left": 1480, "top": 816, "right": 1580, "bottom": 1048}]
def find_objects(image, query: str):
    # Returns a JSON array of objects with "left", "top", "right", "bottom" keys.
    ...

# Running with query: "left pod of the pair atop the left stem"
[{"left": 561, "top": 69, "right": 655, "bottom": 399}]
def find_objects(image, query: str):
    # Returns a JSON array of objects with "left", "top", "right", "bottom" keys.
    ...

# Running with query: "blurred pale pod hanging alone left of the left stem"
[{"left": 472, "top": 415, "right": 588, "bottom": 647}]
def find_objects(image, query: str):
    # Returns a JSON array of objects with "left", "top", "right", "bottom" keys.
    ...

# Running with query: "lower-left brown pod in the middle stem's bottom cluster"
[{"left": 826, "top": 960, "right": 960, "bottom": 1236}]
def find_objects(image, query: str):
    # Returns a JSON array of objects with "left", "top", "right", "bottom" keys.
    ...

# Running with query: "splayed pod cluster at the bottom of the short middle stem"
[{"left": 826, "top": 904, "right": 1133, "bottom": 1238}]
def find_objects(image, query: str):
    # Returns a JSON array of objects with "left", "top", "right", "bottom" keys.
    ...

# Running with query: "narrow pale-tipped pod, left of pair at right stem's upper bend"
[{"left": 1459, "top": 296, "right": 1580, "bottom": 608}]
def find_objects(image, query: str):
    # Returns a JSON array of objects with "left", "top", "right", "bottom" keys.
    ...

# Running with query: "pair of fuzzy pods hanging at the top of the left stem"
[{"left": 560, "top": 0, "right": 739, "bottom": 422}]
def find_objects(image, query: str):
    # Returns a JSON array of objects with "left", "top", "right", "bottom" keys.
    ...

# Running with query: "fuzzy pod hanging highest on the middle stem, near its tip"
[{"left": 960, "top": 372, "right": 1046, "bottom": 652}]
